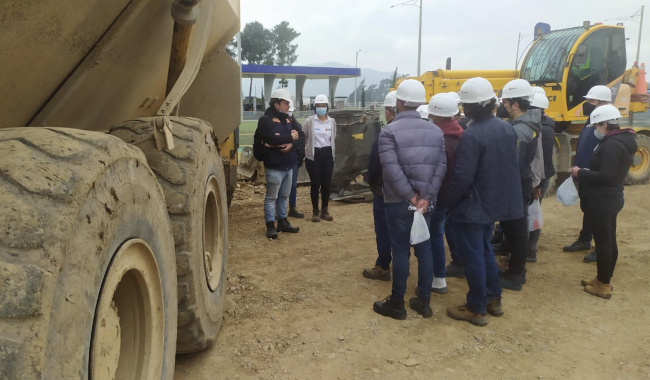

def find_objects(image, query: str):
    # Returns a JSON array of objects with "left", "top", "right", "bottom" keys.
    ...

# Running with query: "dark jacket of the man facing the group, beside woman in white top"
[{"left": 253, "top": 107, "right": 297, "bottom": 170}]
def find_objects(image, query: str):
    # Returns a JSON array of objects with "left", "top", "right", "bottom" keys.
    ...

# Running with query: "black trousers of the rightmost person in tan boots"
[{"left": 585, "top": 197, "right": 625, "bottom": 284}]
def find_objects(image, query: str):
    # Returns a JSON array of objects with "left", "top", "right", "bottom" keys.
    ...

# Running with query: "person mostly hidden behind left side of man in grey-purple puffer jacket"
[{"left": 362, "top": 91, "right": 397, "bottom": 281}]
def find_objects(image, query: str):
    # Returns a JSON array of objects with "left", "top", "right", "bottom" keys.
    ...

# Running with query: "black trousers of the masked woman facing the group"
[{"left": 305, "top": 147, "right": 334, "bottom": 210}]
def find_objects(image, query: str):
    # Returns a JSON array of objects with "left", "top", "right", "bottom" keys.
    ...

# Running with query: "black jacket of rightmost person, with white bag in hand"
[{"left": 578, "top": 129, "right": 637, "bottom": 198}]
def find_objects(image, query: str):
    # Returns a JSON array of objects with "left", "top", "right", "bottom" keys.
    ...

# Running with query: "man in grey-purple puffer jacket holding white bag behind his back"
[{"left": 373, "top": 79, "right": 447, "bottom": 319}]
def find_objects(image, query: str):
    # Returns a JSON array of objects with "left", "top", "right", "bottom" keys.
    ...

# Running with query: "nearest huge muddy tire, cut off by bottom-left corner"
[{"left": 0, "top": 128, "right": 178, "bottom": 380}]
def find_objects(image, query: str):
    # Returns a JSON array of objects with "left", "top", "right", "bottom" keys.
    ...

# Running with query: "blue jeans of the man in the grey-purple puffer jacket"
[{"left": 384, "top": 201, "right": 433, "bottom": 302}]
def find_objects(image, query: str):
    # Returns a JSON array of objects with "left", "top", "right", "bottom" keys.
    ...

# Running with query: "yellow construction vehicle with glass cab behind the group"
[{"left": 397, "top": 22, "right": 650, "bottom": 192}]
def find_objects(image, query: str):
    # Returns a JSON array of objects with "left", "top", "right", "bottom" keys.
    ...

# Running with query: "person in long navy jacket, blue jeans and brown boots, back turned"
[{"left": 444, "top": 78, "right": 524, "bottom": 326}]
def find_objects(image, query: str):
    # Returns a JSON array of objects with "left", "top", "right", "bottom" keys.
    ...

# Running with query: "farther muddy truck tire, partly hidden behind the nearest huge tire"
[{"left": 110, "top": 117, "right": 228, "bottom": 353}]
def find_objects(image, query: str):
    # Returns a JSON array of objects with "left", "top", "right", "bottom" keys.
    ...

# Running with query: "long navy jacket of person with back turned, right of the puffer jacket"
[{"left": 445, "top": 116, "right": 524, "bottom": 224}]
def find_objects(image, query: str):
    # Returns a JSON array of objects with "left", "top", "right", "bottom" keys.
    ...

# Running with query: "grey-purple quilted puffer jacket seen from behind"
[{"left": 379, "top": 111, "right": 447, "bottom": 203}]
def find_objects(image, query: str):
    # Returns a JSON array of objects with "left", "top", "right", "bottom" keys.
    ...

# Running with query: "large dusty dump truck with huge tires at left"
[{"left": 0, "top": 0, "right": 241, "bottom": 380}]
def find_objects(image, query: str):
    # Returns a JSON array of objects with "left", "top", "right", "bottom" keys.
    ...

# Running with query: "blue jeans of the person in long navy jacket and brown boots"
[{"left": 452, "top": 222, "right": 501, "bottom": 314}]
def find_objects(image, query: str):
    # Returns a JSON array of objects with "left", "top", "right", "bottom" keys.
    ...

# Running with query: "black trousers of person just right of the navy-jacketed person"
[{"left": 499, "top": 179, "right": 533, "bottom": 275}]
